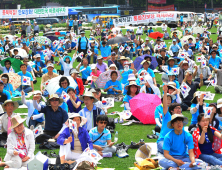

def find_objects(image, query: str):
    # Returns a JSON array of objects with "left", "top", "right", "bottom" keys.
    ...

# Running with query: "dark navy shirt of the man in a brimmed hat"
[{"left": 39, "top": 105, "right": 68, "bottom": 132}]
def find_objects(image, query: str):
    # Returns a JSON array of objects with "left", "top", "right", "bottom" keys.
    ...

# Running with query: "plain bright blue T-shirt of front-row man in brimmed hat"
[{"left": 161, "top": 129, "right": 194, "bottom": 157}]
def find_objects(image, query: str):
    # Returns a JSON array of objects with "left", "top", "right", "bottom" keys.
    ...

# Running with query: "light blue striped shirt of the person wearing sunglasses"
[{"left": 89, "top": 127, "right": 111, "bottom": 146}]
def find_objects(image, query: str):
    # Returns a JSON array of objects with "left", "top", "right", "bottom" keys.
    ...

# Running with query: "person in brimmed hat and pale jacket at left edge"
[{"left": 0, "top": 100, "right": 19, "bottom": 142}]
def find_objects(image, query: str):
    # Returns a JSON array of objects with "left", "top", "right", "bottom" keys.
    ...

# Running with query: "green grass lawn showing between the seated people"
[{"left": 0, "top": 25, "right": 220, "bottom": 170}]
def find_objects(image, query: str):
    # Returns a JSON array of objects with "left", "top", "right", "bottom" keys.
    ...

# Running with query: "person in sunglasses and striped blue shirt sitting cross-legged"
[{"left": 89, "top": 115, "right": 116, "bottom": 157}]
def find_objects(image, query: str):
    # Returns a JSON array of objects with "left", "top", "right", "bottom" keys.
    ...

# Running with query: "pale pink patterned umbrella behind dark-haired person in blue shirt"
[{"left": 95, "top": 70, "right": 122, "bottom": 88}]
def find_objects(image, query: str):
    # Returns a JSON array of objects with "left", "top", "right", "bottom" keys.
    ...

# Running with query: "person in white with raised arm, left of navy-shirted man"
[{"left": 21, "top": 91, "right": 45, "bottom": 129}]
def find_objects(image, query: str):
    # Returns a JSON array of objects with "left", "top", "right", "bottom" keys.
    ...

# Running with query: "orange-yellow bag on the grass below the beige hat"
[{"left": 134, "top": 158, "right": 158, "bottom": 170}]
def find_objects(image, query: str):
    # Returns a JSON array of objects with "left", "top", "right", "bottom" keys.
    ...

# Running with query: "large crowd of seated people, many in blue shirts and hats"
[{"left": 0, "top": 15, "right": 222, "bottom": 170}]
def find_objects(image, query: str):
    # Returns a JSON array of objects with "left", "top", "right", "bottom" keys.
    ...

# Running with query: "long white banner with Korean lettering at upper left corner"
[{"left": 0, "top": 7, "right": 68, "bottom": 18}]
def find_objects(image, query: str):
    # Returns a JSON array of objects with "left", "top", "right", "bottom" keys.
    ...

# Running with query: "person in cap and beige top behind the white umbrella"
[{"left": 40, "top": 63, "right": 59, "bottom": 96}]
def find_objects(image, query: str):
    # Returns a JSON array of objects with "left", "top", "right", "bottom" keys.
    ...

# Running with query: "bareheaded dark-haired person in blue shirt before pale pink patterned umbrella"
[{"left": 104, "top": 71, "right": 122, "bottom": 95}]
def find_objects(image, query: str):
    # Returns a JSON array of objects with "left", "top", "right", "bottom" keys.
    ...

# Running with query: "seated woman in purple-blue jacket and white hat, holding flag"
[{"left": 57, "top": 113, "right": 93, "bottom": 164}]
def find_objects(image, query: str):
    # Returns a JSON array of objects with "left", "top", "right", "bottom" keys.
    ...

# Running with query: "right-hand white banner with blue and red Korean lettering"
[{"left": 114, "top": 12, "right": 177, "bottom": 26}]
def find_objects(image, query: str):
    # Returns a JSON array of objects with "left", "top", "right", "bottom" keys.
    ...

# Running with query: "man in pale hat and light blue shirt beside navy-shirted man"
[{"left": 79, "top": 91, "right": 105, "bottom": 131}]
